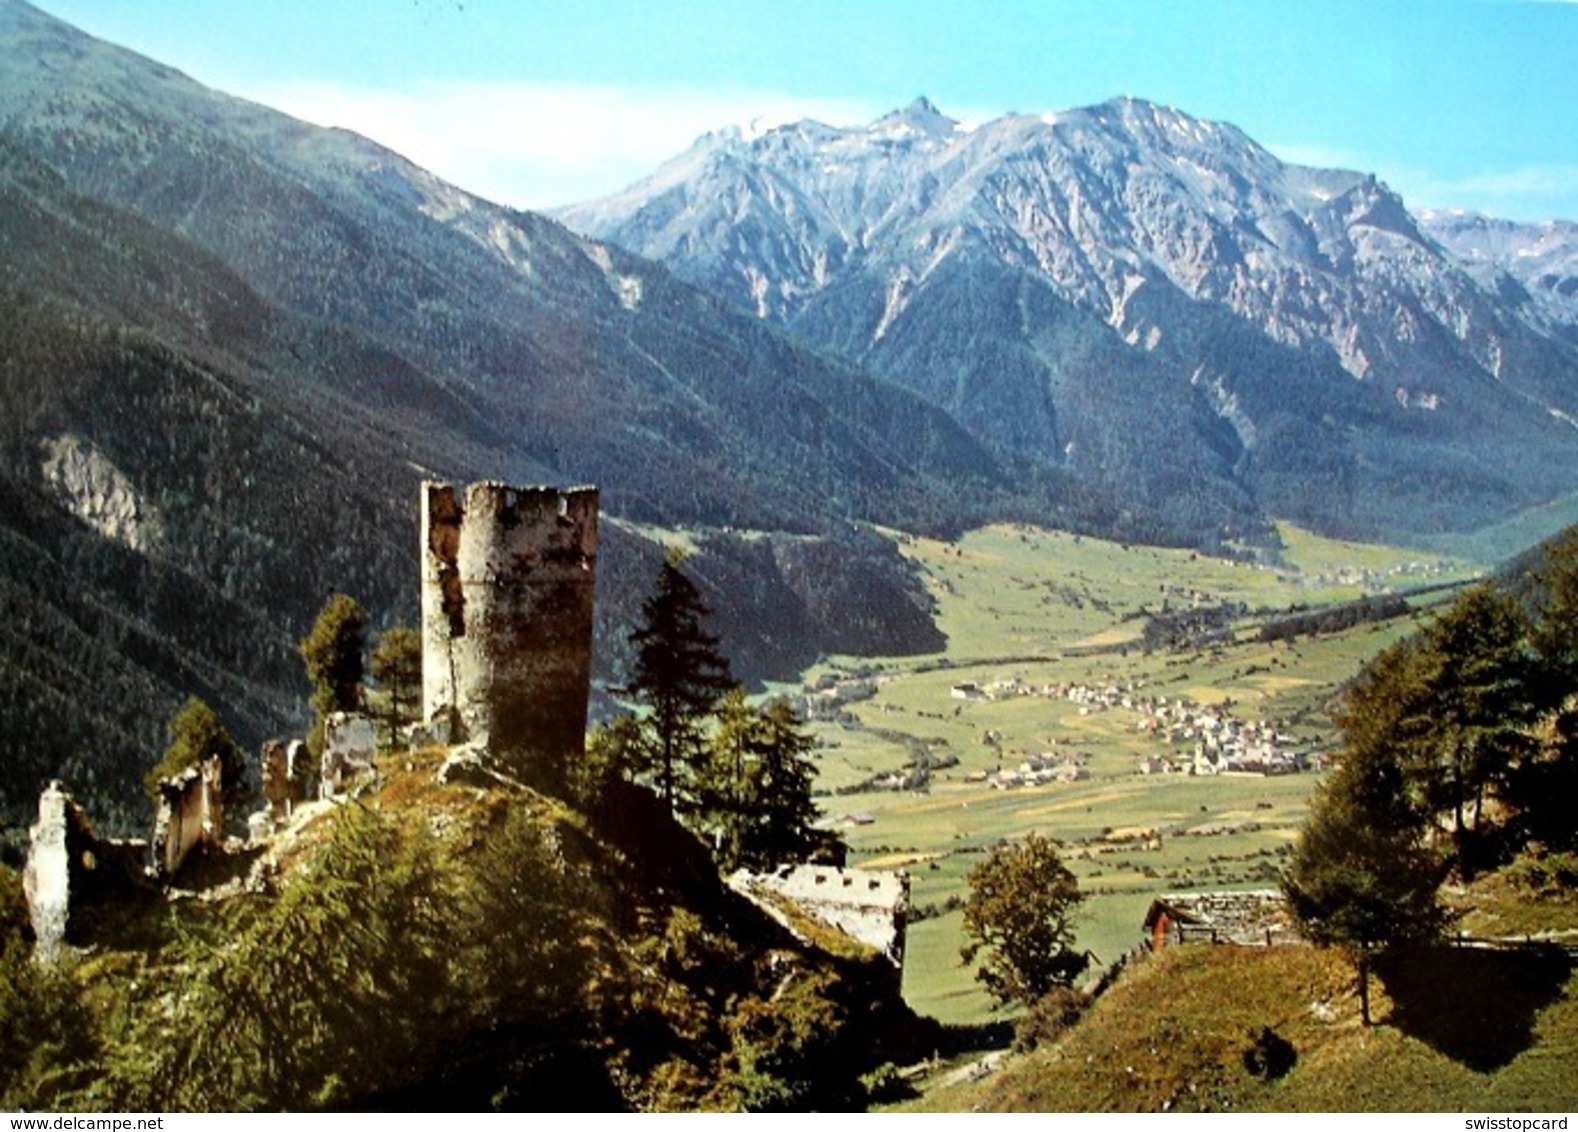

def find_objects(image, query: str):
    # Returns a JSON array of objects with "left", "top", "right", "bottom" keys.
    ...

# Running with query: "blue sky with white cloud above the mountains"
[{"left": 41, "top": 0, "right": 1578, "bottom": 219}]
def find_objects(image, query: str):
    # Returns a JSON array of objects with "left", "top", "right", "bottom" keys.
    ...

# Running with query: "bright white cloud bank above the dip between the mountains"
[{"left": 238, "top": 82, "right": 884, "bottom": 208}]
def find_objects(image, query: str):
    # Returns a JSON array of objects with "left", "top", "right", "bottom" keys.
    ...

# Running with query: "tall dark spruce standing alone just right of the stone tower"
[{"left": 625, "top": 554, "right": 734, "bottom": 812}]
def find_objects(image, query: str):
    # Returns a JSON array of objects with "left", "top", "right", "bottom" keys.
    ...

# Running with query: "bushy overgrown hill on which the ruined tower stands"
[{"left": 0, "top": 750, "right": 937, "bottom": 1111}]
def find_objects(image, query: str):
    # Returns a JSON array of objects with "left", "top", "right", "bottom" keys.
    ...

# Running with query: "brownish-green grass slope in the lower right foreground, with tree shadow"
[{"left": 917, "top": 946, "right": 1578, "bottom": 1111}]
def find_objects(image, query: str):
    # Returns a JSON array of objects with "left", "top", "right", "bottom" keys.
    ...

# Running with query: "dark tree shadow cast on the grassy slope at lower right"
[{"left": 1376, "top": 947, "right": 1572, "bottom": 1074}]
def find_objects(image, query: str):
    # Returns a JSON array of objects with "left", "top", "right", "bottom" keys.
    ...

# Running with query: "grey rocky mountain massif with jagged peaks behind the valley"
[{"left": 560, "top": 99, "right": 1578, "bottom": 535}]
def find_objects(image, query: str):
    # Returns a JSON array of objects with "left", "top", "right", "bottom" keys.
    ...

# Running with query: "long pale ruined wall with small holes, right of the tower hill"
[{"left": 729, "top": 865, "right": 909, "bottom": 969}]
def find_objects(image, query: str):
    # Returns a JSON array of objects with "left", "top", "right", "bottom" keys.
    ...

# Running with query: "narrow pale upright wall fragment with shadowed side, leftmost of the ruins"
[{"left": 22, "top": 782, "right": 148, "bottom": 961}]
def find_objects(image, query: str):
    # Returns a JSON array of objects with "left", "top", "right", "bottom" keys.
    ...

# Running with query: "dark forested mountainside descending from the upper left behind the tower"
[{"left": 0, "top": 0, "right": 1136, "bottom": 829}]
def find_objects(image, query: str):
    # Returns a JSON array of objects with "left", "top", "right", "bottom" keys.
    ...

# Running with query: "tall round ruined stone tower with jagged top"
[{"left": 421, "top": 482, "right": 598, "bottom": 786}]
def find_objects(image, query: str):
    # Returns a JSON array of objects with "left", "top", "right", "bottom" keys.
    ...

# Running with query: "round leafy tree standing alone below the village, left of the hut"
[{"left": 959, "top": 832, "right": 1087, "bottom": 1006}]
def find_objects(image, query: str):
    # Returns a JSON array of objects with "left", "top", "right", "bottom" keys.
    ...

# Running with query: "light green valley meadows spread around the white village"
[{"left": 806, "top": 526, "right": 1477, "bottom": 1023}]
